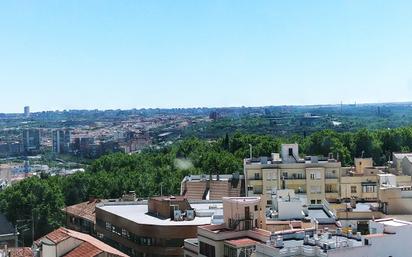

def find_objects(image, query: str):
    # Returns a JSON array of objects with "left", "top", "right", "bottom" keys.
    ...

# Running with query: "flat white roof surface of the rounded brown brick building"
[{"left": 96, "top": 202, "right": 223, "bottom": 226}]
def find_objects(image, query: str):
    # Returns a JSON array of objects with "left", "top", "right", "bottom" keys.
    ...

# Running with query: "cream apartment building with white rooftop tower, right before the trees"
[{"left": 244, "top": 144, "right": 341, "bottom": 205}]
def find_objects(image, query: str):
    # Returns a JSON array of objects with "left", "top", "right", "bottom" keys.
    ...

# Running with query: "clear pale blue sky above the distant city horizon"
[{"left": 0, "top": 0, "right": 412, "bottom": 112}]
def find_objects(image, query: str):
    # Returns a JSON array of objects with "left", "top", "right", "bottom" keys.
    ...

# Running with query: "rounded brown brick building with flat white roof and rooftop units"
[{"left": 96, "top": 196, "right": 223, "bottom": 256}]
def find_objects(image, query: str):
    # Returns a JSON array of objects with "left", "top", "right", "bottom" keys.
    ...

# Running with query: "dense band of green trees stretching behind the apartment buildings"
[{"left": 4, "top": 127, "right": 412, "bottom": 242}]
